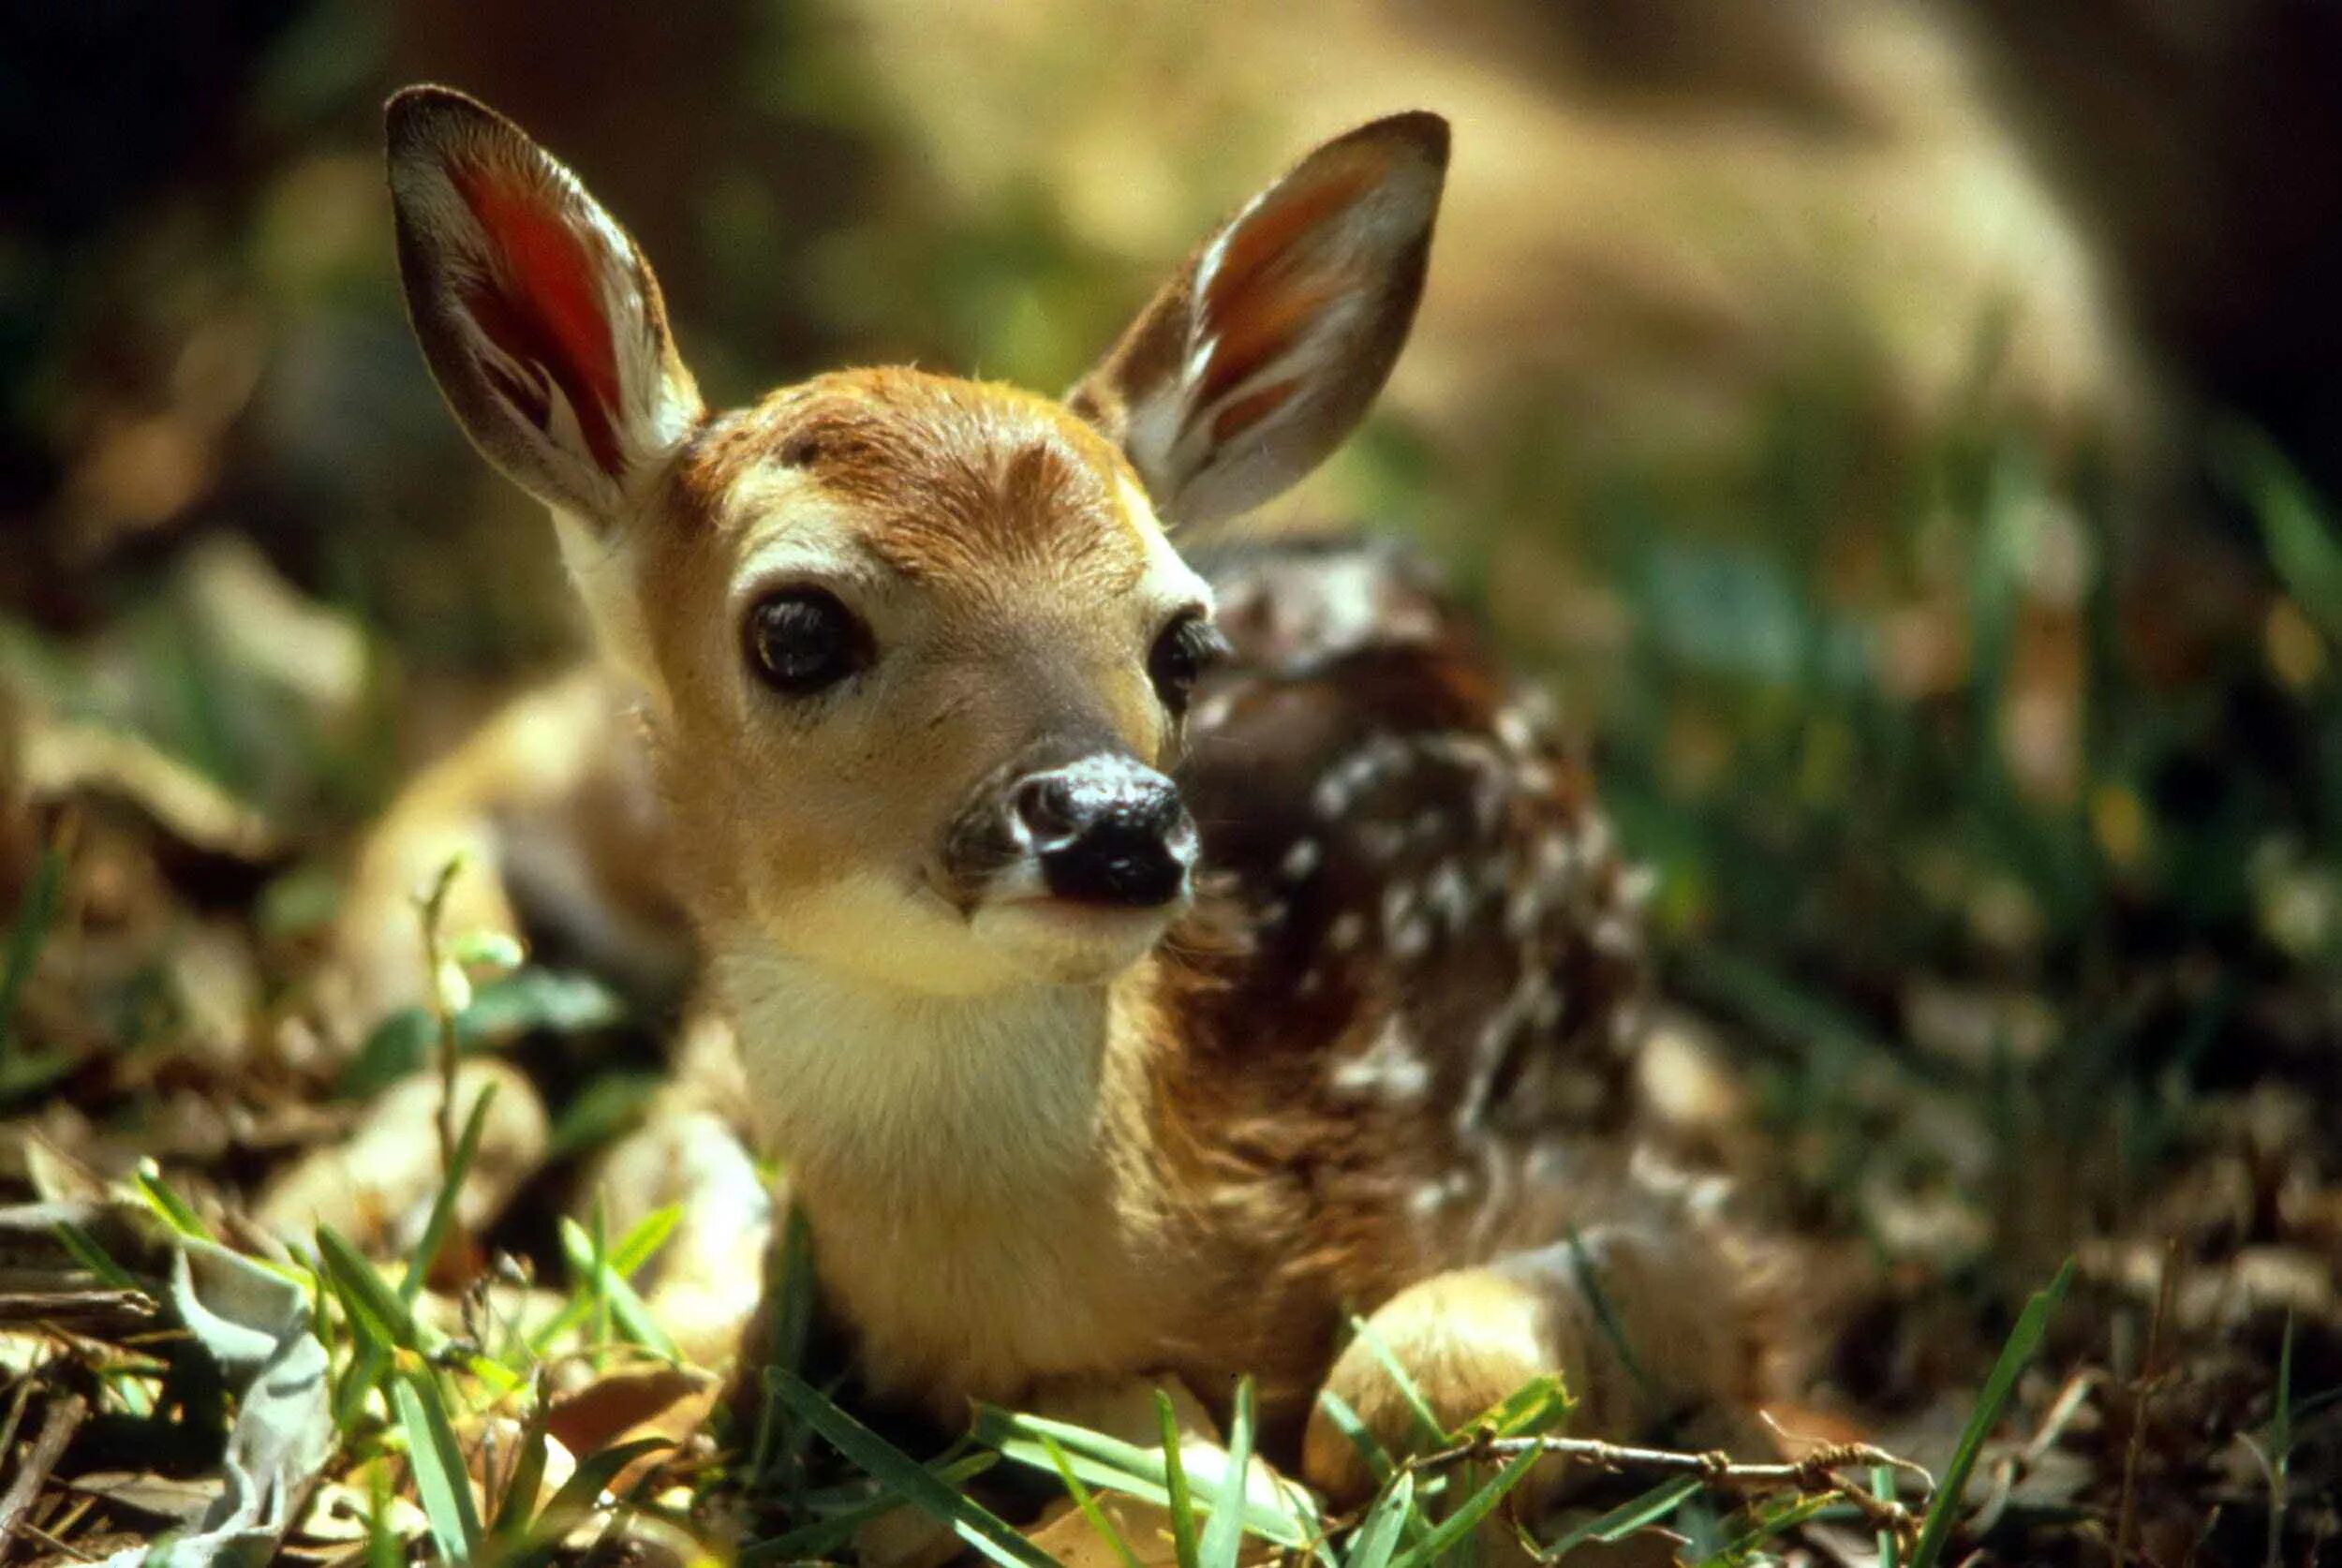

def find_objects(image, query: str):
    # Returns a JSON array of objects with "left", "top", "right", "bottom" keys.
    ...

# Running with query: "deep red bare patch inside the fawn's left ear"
[{"left": 450, "top": 166, "right": 618, "bottom": 475}]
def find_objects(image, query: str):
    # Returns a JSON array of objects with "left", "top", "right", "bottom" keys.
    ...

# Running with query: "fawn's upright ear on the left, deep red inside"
[{"left": 387, "top": 86, "right": 701, "bottom": 526}]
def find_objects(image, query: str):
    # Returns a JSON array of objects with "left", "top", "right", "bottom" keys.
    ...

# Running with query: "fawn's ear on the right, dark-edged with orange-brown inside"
[{"left": 1068, "top": 112, "right": 1447, "bottom": 525}]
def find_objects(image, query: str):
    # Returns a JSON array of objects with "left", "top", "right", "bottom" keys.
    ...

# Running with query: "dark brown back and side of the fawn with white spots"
[{"left": 1178, "top": 543, "right": 1639, "bottom": 1294}]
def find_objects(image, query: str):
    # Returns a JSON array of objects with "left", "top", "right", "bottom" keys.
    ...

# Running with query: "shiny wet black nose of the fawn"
[{"left": 1015, "top": 754, "right": 1194, "bottom": 908}]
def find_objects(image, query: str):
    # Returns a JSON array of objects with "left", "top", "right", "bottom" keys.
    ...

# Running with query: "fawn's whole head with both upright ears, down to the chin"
[{"left": 389, "top": 86, "right": 1447, "bottom": 995}]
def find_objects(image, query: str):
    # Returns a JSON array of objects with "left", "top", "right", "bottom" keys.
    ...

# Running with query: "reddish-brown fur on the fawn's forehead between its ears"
[{"left": 677, "top": 370, "right": 1155, "bottom": 585}]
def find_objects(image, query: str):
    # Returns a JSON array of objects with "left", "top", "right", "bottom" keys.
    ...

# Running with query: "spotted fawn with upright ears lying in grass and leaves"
[{"left": 389, "top": 86, "right": 1761, "bottom": 1493}]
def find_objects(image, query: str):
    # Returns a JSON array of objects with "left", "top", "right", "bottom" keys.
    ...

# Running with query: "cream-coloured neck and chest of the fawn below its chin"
[{"left": 719, "top": 959, "right": 1227, "bottom": 1421}]
